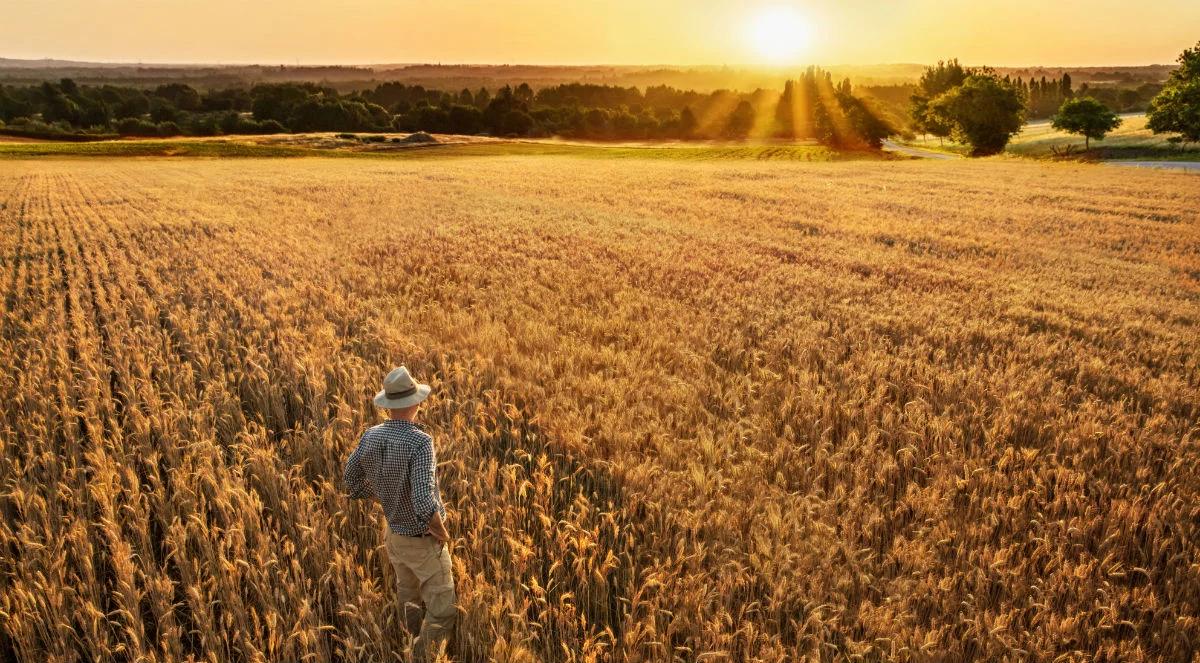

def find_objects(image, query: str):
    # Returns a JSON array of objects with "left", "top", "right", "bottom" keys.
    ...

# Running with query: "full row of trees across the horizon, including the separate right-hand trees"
[{"left": 0, "top": 44, "right": 1200, "bottom": 155}]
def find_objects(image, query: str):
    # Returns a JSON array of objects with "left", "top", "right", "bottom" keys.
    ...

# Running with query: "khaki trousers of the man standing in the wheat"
[{"left": 388, "top": 531, "right": 458, "bottom": 661}]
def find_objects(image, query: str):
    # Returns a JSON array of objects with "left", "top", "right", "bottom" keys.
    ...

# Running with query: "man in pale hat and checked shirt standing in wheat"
[{"left": 346, "top": 366, "right": 457, "bottom": 658}]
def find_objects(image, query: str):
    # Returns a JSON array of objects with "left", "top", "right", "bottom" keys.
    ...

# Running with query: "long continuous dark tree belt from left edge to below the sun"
[{"left": 0, "top": 67, "right": 894, "bottom": 148}]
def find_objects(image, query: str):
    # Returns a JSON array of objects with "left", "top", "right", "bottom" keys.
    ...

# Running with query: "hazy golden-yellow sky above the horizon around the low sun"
[{"left": 0, "top": 0, "right": 1200, "bottom": 65}]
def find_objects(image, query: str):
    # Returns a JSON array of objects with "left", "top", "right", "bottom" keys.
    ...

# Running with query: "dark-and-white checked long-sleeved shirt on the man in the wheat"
[{"left": 344, "top": 419, "right": 446, "bottom": 537}]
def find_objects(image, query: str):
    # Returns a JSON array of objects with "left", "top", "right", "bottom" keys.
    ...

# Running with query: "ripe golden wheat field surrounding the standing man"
[{"left": 0, "top": 154, "right": 1200, "bottom": 663}]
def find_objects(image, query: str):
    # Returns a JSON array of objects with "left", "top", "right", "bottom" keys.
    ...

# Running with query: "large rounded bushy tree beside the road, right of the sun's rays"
[{"left": 929, "top": 71, "right": 1025, "bottom": 156}]
